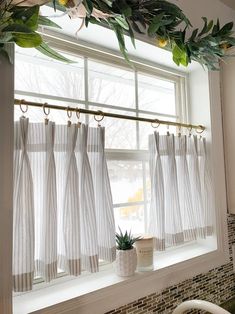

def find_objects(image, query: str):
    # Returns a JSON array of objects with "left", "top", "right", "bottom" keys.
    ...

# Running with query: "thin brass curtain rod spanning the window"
[{"left": 14, "top": 99, "right": 206, "bottom": 133}]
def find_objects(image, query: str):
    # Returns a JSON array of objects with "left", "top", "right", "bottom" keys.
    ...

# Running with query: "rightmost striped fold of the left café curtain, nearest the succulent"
[{"left": 87, "top": 127, "right": 116, "bottom": 262}]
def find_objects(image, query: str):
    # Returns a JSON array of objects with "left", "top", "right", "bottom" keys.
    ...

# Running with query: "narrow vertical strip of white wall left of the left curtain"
[{"left": 0, "top": 45, "right": 14, "bottom": 314}]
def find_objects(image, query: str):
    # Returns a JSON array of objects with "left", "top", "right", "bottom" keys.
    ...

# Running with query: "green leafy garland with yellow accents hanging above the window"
[{"left": 0, "top": 0, "right": 235, "bottom": 70}]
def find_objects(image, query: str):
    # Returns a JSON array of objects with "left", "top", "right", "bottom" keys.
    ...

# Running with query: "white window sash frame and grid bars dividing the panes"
[{"left": 15, "top": 33, "right": 188, "bottom": 242}]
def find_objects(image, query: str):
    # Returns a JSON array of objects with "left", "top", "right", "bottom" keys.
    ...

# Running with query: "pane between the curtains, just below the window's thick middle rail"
[{"left": 108, "top": 160, "right": 144, "bottom": 204}]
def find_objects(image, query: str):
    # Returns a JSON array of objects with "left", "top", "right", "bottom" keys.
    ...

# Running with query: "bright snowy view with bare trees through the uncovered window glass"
[{"left": 15, "top": 48, "right": 179, "bottom": 234}]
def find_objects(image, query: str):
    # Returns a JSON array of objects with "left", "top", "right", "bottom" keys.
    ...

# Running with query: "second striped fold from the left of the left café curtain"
[{"left": 28, "top": 122, "right": 57, "bottom": 281}]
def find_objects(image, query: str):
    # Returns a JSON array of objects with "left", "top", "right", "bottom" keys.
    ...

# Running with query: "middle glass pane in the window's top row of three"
[{"left": 88, "top": 61, "right": 135, "bottom": 108}]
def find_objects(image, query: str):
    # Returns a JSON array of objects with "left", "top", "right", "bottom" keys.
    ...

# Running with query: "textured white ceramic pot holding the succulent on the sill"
[{"left": 116, "top": 248, "right": 137, "bottom": 277}]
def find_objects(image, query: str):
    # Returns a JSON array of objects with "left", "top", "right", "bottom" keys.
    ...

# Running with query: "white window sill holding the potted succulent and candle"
[{"left": 13, "top": 243, "right": 227, "bottom": 314}]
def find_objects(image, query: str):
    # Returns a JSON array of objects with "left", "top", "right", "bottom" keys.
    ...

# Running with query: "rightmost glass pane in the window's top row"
[{"left": 138, "top": 74, "right": 176, "bottom": 115}]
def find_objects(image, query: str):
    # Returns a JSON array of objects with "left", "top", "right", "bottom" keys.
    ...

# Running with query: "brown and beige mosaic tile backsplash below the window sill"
[{"left": 105, "top": 215, "right": 235, "bottom": 314}]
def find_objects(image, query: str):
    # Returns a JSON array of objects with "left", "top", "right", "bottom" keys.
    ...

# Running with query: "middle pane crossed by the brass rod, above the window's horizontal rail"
[{"left": 89, "top": 106, "right": 137, "bottom": 149}]
